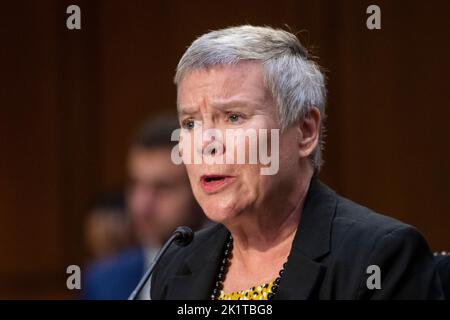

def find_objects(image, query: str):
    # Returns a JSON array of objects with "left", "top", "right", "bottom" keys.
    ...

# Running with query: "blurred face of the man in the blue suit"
[{"left": 128, "top": 147, "right": 195, "bottom": 245}]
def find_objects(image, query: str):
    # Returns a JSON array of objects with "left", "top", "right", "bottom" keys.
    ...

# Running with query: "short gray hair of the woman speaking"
[{"left": 175, "top": 25, "right": 326, "bottom": 172}]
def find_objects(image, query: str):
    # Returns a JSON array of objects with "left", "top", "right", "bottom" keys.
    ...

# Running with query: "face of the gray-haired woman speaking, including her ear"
[{"left": 178, "top": 62, "right": 299, "bottom": 223}]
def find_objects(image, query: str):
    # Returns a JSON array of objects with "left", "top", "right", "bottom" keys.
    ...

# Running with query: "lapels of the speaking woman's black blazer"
[{"left": 167, "top": 178, "right": 336, "bottom": 300}]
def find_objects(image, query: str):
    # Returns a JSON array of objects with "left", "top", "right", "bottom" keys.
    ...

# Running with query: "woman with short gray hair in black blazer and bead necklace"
[{"left": 151, "top": 25, "right": 442, "bottom": 300}]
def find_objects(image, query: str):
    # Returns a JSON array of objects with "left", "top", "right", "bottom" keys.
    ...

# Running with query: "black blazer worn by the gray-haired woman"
[{"left": 151, "top": 178, "right": 443, "bottom": 300}]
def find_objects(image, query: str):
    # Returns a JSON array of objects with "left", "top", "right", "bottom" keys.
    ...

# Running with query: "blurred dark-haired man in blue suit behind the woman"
[{"left": 83, "top": 117, "right": 206, "bottom": 299}]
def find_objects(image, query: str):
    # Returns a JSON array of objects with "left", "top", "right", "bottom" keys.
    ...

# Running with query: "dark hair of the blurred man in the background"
[{"left": 131, "top": 116, "right": 180, "bottom": 149}]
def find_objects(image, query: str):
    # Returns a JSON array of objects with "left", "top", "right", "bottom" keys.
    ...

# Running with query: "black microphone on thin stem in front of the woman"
[{"left": 128, "top": 226, "right": 194, "bottom": 300}]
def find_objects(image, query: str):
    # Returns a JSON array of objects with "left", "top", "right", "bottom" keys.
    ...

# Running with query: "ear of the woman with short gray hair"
[{"left": 298, "top": 107, "right": 321, "bottom": 158}]
